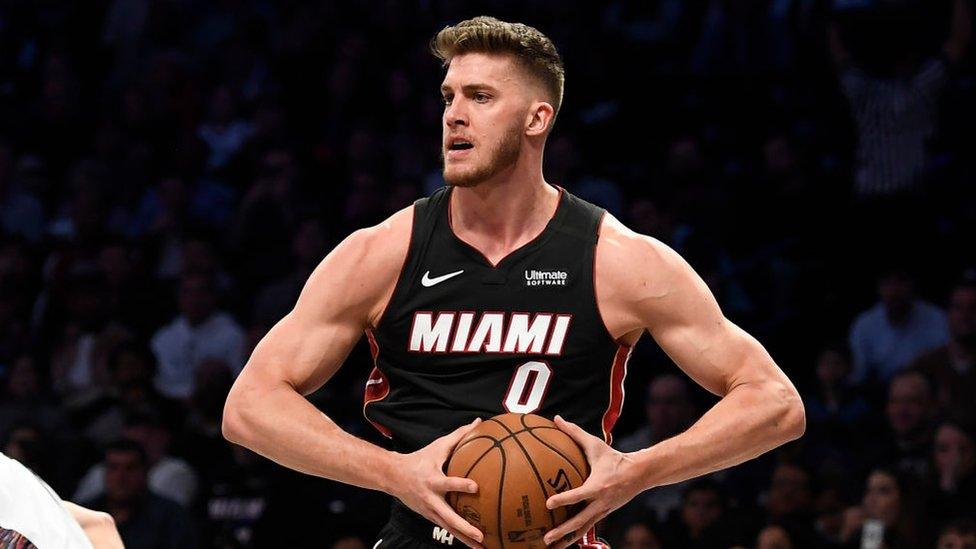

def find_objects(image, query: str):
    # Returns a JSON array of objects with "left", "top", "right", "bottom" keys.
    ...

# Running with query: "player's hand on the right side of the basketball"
[{"left": 543, "top": 416, "right": 641, "bottom": 549}]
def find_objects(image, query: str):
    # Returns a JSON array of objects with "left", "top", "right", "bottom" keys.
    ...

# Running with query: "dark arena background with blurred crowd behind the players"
[{"left": 0, "top": 0, "right": 976, "bottom": 549}]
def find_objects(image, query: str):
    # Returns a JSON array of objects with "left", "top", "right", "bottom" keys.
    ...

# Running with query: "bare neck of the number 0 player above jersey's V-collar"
[{"left": 450, "top": 162, "right": 559, "bottom": 262}]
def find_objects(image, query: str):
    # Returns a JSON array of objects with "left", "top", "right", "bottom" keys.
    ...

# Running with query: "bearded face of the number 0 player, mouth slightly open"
[{"left": 441, "top": 53, "right": 534, "bottom": 187}]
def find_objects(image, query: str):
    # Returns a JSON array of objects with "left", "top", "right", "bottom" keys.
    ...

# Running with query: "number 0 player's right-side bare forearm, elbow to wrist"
[{"left": 630, "top": 381, "right": 804, "bottom": 489}]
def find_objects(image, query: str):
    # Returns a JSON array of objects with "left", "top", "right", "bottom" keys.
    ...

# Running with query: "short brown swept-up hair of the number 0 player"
[{"left": 430, "top": 15, "right": 566, "bottom": 119}]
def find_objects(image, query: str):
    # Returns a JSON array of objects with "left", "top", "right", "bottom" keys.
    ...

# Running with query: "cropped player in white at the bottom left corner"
[{"left": 0, "top": 453, "right": 122, "bottom": 549}]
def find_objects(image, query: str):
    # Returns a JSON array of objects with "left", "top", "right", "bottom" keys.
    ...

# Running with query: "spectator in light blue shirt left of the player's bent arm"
[{"left": 151, "top": 274, "right": 245, "bottom": 399}]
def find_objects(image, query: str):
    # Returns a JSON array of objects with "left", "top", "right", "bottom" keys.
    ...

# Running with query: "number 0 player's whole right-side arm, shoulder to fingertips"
[{"left": 546, "top": 216, "right": 805, "bottom": 549}]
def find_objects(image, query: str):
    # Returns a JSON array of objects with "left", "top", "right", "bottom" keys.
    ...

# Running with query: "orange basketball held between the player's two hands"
[{"left": 447, "top": 414, "right": 590, "bottom": 549}]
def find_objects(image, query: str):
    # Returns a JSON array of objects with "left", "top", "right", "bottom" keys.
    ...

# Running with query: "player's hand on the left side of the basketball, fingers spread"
[{"left": 390, "top": 418, "right": 483, "bottom": 549}]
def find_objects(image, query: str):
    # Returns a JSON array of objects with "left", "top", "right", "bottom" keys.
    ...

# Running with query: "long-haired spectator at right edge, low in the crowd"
[{"left": 928, "top": 420, "right": 976, "bottom": 521}]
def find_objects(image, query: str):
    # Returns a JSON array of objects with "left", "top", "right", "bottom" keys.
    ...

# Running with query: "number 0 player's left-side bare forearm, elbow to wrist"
[{"left": 224, "top": 383, "right": 397, "bottom": 493}]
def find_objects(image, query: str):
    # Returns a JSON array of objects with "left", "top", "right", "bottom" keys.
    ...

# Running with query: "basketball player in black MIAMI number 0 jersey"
[{"left": 223, "top": 17, "right": 805, "bottom": 549}]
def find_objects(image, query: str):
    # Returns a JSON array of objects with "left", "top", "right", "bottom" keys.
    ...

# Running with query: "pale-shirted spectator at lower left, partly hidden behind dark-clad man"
[{"left": 73, "top": 412, "right": 199, "bottom": 508}]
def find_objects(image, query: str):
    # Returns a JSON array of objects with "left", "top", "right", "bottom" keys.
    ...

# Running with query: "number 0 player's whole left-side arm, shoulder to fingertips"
[{"left": 223, "top": 208, "right": 481, "bottom": 545}]
